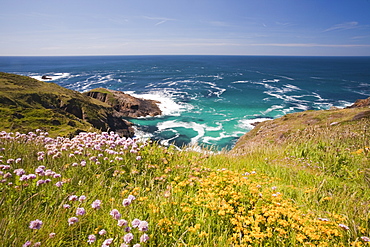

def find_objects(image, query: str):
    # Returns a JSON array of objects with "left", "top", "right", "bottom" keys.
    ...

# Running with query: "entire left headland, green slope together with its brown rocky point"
[{"left": 0, "top": 72, "right": 161, "bottom": 137}]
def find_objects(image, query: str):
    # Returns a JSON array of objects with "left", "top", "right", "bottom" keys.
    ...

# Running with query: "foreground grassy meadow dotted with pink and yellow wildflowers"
[{"left": 0, "top": 121, "right": 370, "bottom": 247}]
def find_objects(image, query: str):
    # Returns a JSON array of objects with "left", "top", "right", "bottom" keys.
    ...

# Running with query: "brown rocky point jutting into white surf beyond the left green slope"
[{"left": 84, "top": 88, "right": 162, "bottom": 118}]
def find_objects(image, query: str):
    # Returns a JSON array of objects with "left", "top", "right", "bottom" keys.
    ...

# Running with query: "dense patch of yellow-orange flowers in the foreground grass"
[{"left": 175, "top": 169, "right": 342, "bottom": 246}]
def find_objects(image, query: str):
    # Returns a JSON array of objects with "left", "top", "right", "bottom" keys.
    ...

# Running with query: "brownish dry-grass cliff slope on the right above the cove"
[{"left": 231, "top": 97, "right": 370, "bottom": 154}]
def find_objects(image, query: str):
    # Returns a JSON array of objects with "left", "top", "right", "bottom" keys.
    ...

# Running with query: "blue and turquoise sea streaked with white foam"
[{"left": 0, "top": 56, "right": 370, "bottom": 149}]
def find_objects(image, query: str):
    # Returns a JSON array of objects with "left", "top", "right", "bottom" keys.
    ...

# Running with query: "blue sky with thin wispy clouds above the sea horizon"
[{"left": 0, "top": 0, "right": 370, "bottom": 56}]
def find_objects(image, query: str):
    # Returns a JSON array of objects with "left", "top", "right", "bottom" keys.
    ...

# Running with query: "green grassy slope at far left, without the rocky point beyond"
[{"left": 0, "top": 72, "right": 133, "bottom": 137}]
